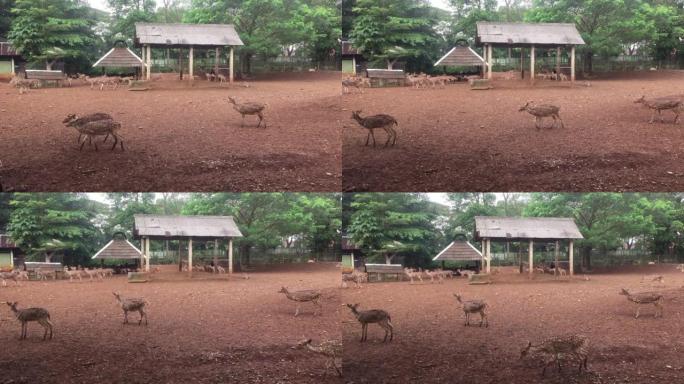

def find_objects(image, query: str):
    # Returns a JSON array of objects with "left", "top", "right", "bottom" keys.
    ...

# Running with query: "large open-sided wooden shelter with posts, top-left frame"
[{"left": 135, "top": 23, "right": 244, "bottom": 83}]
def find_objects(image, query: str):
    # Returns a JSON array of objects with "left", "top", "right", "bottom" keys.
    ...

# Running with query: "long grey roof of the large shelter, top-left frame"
[{"left": 135, "top": 23, "right": 244, "bottom": 47}]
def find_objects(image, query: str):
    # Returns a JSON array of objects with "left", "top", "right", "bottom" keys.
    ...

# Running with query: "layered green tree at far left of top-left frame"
[{"left": 8, "top": 0, "right": 95, "bottom": 69}]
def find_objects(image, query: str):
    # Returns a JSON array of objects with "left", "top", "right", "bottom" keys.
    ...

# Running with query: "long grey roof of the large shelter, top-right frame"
[{"left": 477, "top": 21, "right": 584, "bottom": 45}]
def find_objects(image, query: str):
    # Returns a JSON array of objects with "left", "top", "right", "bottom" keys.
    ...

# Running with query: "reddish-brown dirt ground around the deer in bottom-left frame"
[{"left": 0, "top": 263, "right": 341, "bottom": 383}]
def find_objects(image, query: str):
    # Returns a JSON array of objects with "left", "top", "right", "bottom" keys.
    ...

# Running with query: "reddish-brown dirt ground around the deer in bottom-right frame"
[{"left": 342, "top": 265, "right": 684, "bottom": 384}]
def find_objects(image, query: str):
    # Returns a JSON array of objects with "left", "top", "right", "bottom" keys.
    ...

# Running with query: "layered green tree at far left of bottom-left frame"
[{"left": 7, "top": 193, "right": 102, "bottom": 263}]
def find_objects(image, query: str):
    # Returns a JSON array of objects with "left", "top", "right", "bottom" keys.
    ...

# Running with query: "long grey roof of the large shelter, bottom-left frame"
[{"left": 133, "top": 215, "right": 242, "bottom": 239}]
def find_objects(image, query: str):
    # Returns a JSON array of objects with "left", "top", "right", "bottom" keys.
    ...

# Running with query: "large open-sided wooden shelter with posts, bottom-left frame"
[{"left": 133, "top": 215, "right": 242, "bottom": 276}]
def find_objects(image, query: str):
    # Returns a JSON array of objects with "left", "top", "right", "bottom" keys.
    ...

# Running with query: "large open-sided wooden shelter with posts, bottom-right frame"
[{"left": 475, "top": 216, "right": 584, "bottom": 276}]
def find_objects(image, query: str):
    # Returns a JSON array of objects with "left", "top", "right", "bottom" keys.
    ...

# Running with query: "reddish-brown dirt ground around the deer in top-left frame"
[{"left": 0, "top": 72, "right": 341, "bottom": 192}]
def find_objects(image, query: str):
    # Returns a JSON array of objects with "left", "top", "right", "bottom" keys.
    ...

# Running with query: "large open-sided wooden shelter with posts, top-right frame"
[{"left": 476, "top": 21, "right": 585, "bottom": 84}]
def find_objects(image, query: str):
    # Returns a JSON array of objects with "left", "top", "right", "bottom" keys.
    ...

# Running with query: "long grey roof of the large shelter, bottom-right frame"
[{"left": 475, "top": 216, "right": 584, "bottom": 240}]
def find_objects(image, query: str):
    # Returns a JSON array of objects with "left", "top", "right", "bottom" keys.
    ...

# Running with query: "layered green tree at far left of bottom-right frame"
[{"left": 346, "top": 193, "right": 438, "bottom": 265}]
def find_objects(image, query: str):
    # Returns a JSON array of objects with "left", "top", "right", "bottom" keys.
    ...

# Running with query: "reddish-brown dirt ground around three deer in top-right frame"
[{"left": 342, "top": 71, "right": 684, "bottom": 192}]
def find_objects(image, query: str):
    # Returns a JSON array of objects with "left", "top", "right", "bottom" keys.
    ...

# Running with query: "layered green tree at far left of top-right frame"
[{"left": 350, "top": 0, "right": 439, "bottom": 69}]
